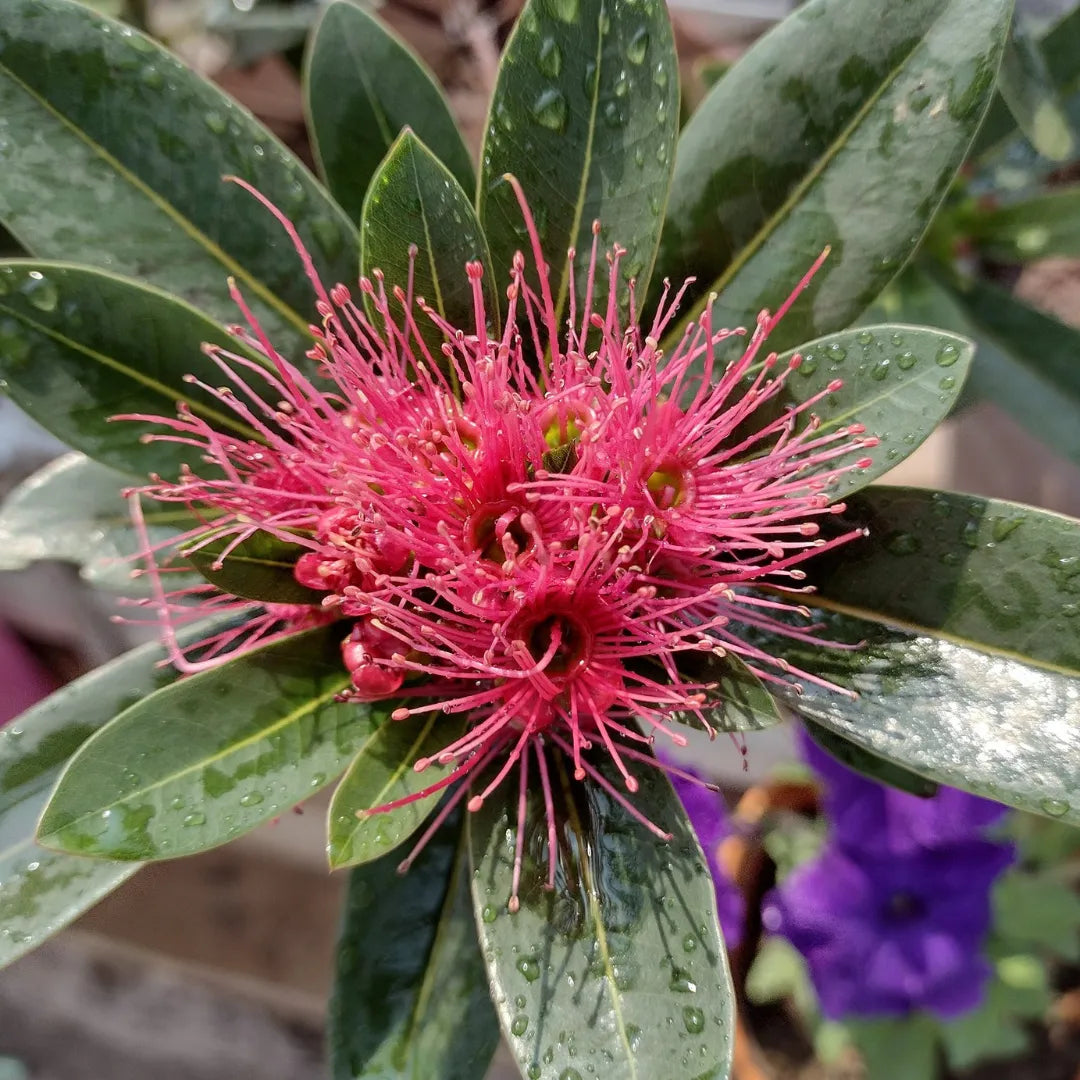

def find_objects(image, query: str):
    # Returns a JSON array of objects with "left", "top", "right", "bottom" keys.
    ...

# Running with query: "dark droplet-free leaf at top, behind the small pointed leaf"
[{"left": 303, "top": 0, "right": 475, "bottom": 224}]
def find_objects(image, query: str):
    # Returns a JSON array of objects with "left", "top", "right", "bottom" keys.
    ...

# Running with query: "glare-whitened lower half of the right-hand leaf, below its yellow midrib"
[{"left": 772, "top": 609, "right": 1080, "bottom": 824}]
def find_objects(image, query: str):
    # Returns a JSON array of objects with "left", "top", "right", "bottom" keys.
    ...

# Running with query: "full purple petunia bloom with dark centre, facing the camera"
[{"left": 764, "top": 840, "right": 1012, "bottom": 1020}]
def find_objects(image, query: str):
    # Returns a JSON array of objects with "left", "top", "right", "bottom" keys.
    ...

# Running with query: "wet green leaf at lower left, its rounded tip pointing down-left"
[{"left": 38, "top": 625, "right": 387, "bottom": 859}]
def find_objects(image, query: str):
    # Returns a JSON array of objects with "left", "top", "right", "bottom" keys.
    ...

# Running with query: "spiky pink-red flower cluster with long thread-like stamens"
[{"left": 120, "top": 177, "right": 877, "bottom": 910}]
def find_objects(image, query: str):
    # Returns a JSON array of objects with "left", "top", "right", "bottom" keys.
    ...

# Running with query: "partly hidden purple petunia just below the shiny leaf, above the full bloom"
[{"left": 799, "top": 729, "right": 1009, "bottom": 854}]
